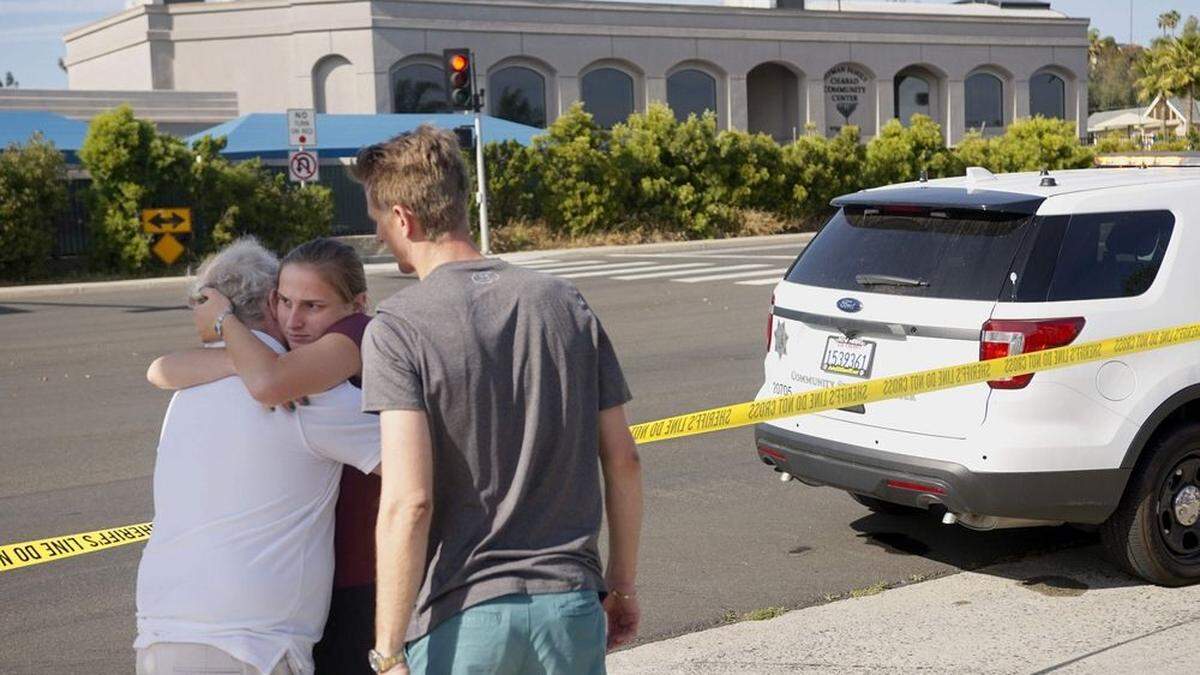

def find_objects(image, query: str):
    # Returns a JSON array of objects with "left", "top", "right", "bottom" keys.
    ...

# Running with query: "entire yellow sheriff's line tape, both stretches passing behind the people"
[{"left": 11, "top": 323, "right": 1200, "bottom": 572}]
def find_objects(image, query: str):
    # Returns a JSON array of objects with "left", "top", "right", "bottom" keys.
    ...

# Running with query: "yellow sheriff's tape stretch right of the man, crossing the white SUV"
[{"left": 629, "top": 323, "right": 1200, "bottom": 444}]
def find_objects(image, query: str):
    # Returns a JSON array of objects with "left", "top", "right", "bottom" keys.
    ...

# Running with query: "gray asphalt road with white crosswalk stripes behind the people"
[{"left": 0, "top": 239, "right": 1088, "bottom": 674}]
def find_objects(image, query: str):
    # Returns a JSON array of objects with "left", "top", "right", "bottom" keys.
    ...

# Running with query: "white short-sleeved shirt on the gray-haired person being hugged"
[{"left": 133, "top": 331, "right": 379, "bottom": 674}]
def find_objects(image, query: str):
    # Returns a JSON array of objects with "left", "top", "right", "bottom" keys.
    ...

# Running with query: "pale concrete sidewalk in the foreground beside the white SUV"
[{"left": 608, "top": 546, "right": 1200, "bottom": 675}]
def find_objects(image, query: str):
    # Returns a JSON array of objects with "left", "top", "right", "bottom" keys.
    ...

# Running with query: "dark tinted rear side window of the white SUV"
[{"left": 1001, "top": 211, "right": 1175, "bottom": 303}]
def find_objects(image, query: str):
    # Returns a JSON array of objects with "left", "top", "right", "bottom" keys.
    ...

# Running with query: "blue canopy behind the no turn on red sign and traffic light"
[{"left": 187, "top": 113, "right": 545, "bottom": 160}]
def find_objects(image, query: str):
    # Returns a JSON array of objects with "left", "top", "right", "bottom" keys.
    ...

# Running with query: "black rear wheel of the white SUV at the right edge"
[{"left": 1100, "top": 423, "right": 1200, "bottom": 586}]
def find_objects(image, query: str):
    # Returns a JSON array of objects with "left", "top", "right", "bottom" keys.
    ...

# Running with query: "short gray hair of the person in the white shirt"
[{"left": 190, "top": 237, "right": 280, "bottom": 328}]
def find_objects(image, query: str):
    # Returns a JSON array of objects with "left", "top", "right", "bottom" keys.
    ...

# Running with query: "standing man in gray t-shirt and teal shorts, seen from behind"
[{"left": 355, "top": 127, "right": 642, "bottom": 673}]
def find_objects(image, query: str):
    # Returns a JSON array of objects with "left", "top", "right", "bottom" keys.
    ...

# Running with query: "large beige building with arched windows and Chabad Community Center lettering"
[{"left": 65, "top": 0, "right": 1088, "bottom": 143}]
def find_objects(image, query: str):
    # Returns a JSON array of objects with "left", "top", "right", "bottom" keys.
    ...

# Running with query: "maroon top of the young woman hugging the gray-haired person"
[{"left": 325, "top": 312, "right": 383, "bottom": 589}]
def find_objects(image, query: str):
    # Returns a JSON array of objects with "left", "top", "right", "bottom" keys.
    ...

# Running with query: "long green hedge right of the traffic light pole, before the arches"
[{"left": 485, "top": 104, "right": 1094, "bottom": 238}]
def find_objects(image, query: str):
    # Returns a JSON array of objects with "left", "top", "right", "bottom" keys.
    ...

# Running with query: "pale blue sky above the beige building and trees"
[{"left": 0, "top": 0, "right": 1200, "bottom": 89}]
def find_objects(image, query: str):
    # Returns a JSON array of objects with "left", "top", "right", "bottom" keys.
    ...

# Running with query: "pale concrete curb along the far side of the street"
[{"left": 0, "top": 232, "right": 814, "bottom": 300}]
